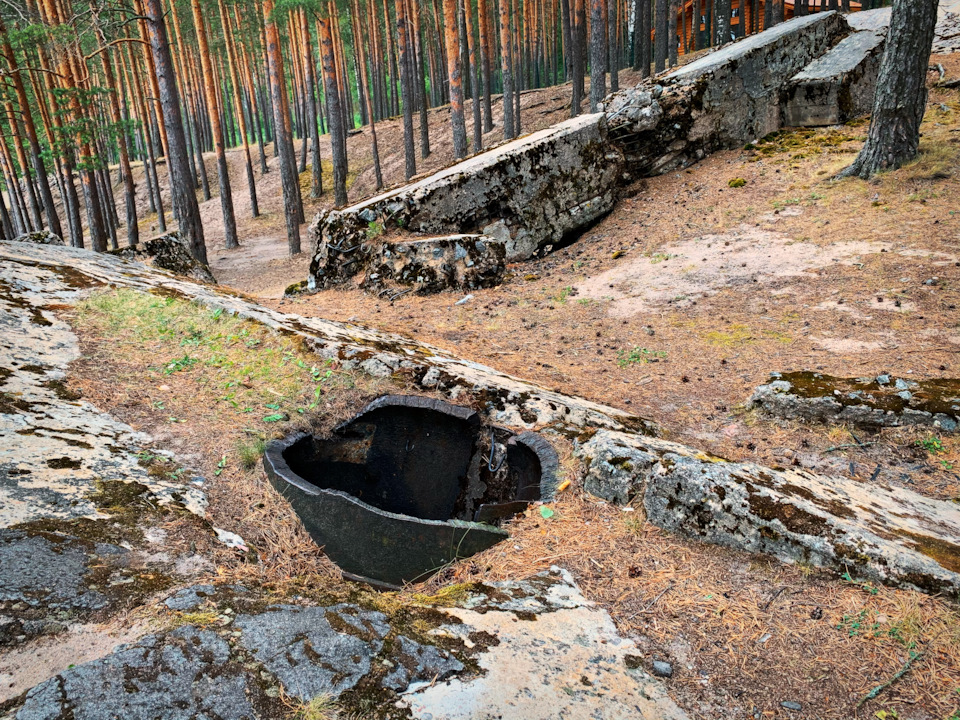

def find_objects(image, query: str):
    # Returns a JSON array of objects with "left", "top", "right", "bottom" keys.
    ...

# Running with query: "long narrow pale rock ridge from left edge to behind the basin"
[{"left": 0, "top": 241, "right": 654, "bottom": 434}]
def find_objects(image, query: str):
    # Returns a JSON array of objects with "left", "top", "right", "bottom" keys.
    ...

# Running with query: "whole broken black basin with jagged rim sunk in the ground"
[{"left": 264, "top": 395, "right": 558, "bottom": 587}]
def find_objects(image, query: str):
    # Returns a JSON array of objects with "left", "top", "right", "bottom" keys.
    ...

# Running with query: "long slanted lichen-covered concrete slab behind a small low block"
[{"left": 310, "top": 113, "right": 623, "bottom": 288}]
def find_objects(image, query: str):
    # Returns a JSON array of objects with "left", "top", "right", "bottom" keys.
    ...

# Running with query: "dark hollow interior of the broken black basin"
[{"left": 284, "top": 402, "right": 542, "bottom": 522}]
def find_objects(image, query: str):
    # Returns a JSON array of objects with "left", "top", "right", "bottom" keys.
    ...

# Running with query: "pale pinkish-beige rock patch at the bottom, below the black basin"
[{"left": 402, "top": 568, "right": 687, "bottom": 720}]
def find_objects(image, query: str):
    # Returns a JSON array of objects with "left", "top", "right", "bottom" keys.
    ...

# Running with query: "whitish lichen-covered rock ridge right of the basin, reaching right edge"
[{"left": 578, "top": 431, "right": 960, "bottom": 597}]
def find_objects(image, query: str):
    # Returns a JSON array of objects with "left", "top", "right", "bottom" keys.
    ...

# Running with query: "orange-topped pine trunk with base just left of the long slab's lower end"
[{"left": 263, "top": 0, "right": 303, "bottom": 255}]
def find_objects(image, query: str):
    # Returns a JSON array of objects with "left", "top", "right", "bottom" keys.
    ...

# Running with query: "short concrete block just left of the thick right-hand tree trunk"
[{"left": 781, "top": 8, "right": 890, "bottom": 127}]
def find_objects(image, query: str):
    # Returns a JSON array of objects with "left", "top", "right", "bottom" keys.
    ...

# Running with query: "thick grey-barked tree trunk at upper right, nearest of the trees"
[{"left": 841, "top": 0, "right": 937, "bottom": 179}]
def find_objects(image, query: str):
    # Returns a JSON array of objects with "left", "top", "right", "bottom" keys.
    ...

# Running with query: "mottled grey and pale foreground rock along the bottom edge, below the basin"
[{"left": 7, "top": 568, "right": 686, "bottom": 720}]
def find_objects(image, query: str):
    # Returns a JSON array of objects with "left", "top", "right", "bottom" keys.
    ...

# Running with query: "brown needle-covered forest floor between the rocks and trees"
[{"left": 88, "top": 55, "right": 960, "bottom": 720}]
